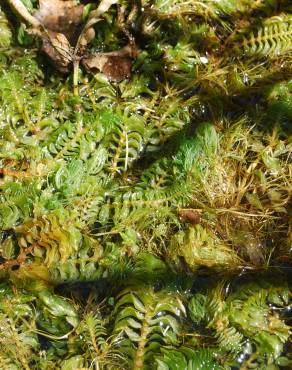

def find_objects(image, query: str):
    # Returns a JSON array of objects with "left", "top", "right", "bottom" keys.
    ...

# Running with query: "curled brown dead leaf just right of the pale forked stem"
[{"left": 82, "top": 45, "right": 137, "bottom": 82}]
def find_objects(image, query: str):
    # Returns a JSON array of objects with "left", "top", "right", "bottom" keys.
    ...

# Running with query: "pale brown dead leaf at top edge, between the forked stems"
[{"left": 34, "top": 0, "right": 84, "bottom": 45}]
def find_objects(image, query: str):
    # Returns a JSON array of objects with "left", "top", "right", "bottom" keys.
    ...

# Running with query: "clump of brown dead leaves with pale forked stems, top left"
[{"left": 9, "top": 0, "right": 137, "bottom": 82}]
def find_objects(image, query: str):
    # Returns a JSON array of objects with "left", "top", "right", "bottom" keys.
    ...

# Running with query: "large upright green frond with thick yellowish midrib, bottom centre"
[{"left": 114, "top": 287, "right": 184, "bottom": 369}]
